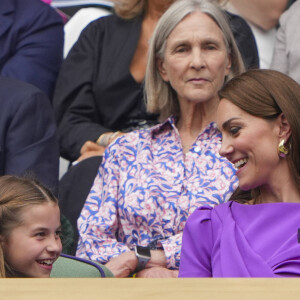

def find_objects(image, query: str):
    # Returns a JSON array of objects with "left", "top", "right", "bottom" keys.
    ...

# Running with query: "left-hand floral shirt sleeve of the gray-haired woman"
[{"left": 76, "top": 143, "right": 130, "bottom": 263}]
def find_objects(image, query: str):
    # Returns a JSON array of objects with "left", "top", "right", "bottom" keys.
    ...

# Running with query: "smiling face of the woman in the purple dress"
[{"left": 217, "top": 99, "right": 282, "bottom": 190}]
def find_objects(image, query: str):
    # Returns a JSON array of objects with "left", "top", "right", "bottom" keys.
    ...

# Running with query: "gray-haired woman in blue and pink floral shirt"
[{"left": 77, "top": 0, "right": 244, "bottom": 277}]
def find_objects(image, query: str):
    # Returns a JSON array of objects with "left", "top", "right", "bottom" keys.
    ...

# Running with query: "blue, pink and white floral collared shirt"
[{"left": 77, "top": 118, "right": 237, "bottom": 269}]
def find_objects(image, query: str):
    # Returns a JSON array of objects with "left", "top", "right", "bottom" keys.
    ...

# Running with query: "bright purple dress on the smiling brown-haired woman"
[{"left": 179, "top": 201, "right": 300, "bottom": 277}]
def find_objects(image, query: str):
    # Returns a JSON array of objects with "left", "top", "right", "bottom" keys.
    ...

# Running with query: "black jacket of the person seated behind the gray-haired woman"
[{"left": 54, "top": 15, "right": 258, "bottom": 161}]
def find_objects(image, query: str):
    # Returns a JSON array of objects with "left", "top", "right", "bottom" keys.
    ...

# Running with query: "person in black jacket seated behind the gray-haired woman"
[{"left": 53, "top": 0, "right": 258, "bottom": 163}]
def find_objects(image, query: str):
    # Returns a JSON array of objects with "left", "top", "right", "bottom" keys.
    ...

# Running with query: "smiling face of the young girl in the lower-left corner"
[{"left": 2, "top": 203, "right": 62, "bottom": 277}]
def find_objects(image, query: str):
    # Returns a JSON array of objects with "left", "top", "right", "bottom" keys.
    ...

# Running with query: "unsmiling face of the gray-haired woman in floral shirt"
[{"left": 158, "top": 12, "right": 231, "bottom": 103}]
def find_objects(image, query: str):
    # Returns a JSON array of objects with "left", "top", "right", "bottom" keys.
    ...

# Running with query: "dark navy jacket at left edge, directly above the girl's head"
[{"left": 0, "top": 76, "right": 59, "bottom": 193}]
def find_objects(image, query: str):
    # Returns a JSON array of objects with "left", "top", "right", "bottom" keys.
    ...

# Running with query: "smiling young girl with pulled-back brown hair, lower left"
[{"left": 0, "top": 175, "right": 62, "bottom": 278}]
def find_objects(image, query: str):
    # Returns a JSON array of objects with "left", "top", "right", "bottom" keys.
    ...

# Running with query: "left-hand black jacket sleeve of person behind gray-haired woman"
[{"left": 53, "top": 18, "right": 110, "bottom": 161}]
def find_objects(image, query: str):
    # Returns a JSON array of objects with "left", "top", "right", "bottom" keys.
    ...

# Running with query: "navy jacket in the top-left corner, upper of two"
[{"left": 0, "top": 0, "right": 64, "bottom": 100}]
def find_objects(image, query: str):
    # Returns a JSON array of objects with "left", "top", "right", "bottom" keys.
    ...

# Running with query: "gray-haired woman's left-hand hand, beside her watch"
[{"left": 105, "top": 251, "right": 138, "bottom": 278}]
